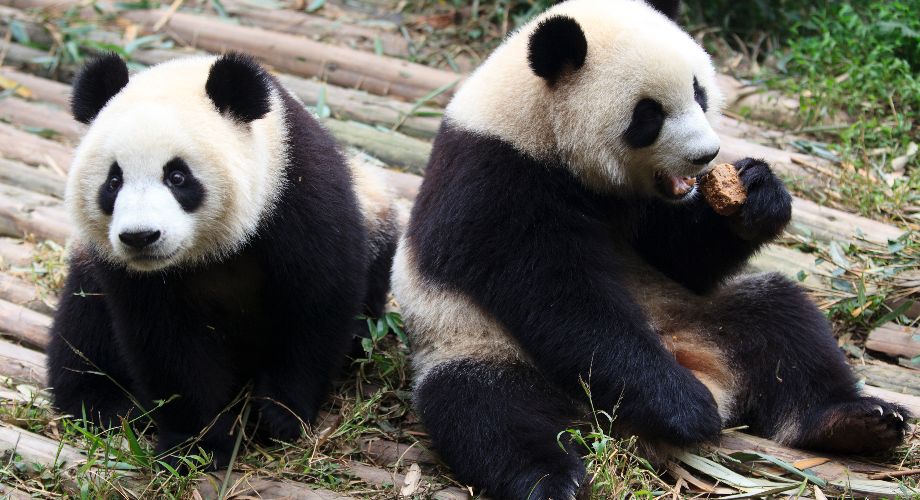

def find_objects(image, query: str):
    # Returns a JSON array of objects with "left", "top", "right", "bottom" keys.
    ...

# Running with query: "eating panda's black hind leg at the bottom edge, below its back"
[{"left": 415, "top": 359, "right": 585, "bottom": 500}]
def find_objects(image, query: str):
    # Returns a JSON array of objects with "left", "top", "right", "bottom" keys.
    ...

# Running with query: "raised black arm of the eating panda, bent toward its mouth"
[{"left": 636, "top": 159, "right": 792, "bottom": 293}]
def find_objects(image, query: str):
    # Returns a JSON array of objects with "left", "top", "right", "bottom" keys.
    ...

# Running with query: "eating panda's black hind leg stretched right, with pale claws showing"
[{"left": 712, "top": 274, "right": 908, "bottom": 453}]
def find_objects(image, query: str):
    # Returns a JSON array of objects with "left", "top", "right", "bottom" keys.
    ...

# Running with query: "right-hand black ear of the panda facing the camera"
[{"left": 205, "top": 52, "right": 272, "bottom": 123}]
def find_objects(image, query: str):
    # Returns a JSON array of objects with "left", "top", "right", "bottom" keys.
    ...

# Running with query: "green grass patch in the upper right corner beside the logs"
[{"left": 772, "top": 0, "right": 920, "bottom": 219}]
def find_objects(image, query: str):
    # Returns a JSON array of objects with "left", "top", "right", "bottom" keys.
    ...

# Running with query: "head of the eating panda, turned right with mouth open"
[{"left": 447, "top": 0, "right": 722, "bottom": 201}]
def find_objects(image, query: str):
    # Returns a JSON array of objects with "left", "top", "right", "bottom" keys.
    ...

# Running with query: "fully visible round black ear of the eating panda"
[{"left": 527, "top": 16, "right": 588, "bottom": 84}]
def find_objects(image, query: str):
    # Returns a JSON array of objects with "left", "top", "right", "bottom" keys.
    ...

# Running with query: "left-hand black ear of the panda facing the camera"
[{"left": 70, "top": 52, "right": 128, "bottom": 124}]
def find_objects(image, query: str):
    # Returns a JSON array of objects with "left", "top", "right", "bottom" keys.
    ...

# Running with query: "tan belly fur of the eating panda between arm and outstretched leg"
[{"left": 621, "top": 250, "right": 738, "bottom": 422}]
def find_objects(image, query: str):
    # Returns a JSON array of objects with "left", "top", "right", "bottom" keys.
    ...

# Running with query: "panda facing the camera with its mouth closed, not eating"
[{"left": 48, "top": 54, "right": 397, "bottom": 467}]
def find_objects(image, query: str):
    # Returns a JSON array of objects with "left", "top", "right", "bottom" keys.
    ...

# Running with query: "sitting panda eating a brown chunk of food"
[{"left": 393, "top": 0, "right": 907, "bottom": 500}]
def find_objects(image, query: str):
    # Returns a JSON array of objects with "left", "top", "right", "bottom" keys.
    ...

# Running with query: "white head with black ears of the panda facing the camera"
[{"left": 66, "top": 54, "right": 286, "bottom": 272}]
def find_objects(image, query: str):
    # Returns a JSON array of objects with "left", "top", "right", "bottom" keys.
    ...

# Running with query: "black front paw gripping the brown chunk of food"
[{"left": 732, "top": 158, "right": 792, "bottom": 243}]
